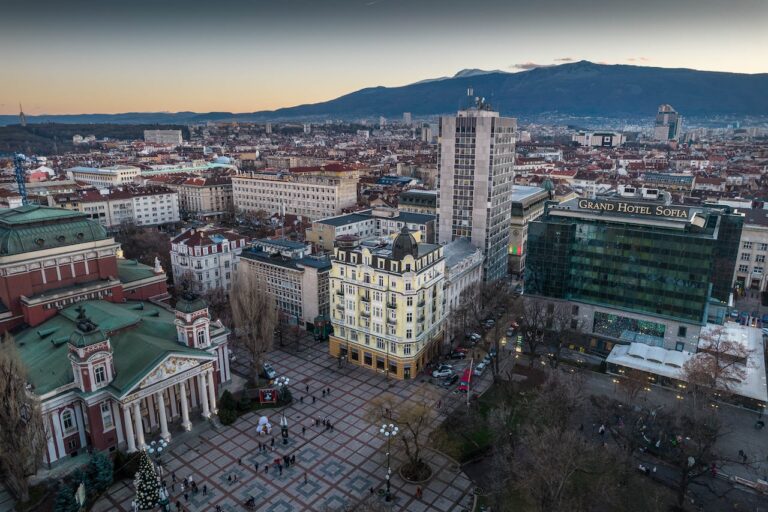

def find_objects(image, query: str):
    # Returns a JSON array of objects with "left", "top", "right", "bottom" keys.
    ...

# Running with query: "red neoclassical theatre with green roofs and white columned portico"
[{"left": 0, "top": 206, "right": 230, "bottom": 463}]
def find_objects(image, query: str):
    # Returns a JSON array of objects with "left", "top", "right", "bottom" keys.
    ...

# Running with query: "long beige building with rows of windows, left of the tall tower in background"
[{"left": 232, "top": 167, "right": 359, "bottom": 219}]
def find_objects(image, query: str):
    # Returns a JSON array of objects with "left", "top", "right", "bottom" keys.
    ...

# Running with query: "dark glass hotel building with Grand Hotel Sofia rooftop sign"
[{"left": 525, "top": 190, "right": 743, "bottom": 354}]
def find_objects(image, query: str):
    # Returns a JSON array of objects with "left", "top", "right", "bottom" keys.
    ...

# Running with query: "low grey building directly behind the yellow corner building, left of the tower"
[{"left": 306, "top": 207, "right": 436, "bottom": 252}]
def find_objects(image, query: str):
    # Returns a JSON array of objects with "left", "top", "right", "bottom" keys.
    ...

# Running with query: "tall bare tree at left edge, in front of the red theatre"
[{"left": 0, "top": 333, "right": 47, "bottom": 502}]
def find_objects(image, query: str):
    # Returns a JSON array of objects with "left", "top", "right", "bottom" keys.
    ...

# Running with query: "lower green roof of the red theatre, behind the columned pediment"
[{"left": 16, "top": 300, "right": 213, "bottom": 396}]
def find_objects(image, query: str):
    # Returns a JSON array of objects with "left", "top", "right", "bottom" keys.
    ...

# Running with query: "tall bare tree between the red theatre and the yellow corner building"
[{"left": 229, "top": 266, "right": 277, "bottom": 386}]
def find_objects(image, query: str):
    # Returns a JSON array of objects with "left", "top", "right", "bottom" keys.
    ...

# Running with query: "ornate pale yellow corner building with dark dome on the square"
[{"left": 328, "top": 228, "right": 445, "bottom": 379}]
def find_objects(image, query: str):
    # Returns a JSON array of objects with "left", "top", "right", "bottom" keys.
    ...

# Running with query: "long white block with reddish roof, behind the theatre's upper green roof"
[{"left": 77, "top": 186, "right": 179, "bottom": 228}]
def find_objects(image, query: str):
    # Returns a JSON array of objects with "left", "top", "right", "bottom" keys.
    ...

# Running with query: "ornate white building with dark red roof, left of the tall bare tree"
[{"left": 171, "top": 229, "right": 246, "bottom": 292}]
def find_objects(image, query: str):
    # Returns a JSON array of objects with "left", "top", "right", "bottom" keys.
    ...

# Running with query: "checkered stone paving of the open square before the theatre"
[{"left": 93, "top": 344, "right": 488, "bottom": 512}]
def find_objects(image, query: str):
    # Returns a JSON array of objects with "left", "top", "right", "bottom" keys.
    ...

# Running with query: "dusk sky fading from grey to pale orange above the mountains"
[{"left": 0, "top": 0, "right": 768, "bottom": 115}]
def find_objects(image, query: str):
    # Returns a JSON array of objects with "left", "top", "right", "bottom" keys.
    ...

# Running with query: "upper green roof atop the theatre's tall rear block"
[{"left": 0, "top": 205, "right": 108, "bottom": 255}]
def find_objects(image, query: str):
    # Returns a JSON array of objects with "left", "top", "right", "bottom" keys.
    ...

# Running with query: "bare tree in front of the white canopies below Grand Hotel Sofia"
[{"left": 683, "top": 327, "right": 751, "bottom": 406}]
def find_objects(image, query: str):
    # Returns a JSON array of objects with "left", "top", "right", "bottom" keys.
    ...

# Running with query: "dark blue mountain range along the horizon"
[{"left": 0, "top": 61, "right": 768, "bottom": 124}]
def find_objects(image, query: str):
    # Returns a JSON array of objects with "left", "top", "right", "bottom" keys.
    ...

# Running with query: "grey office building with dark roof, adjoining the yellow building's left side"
[{"left": 241, "top": 239, "right": 331, "bottom": 329}]
